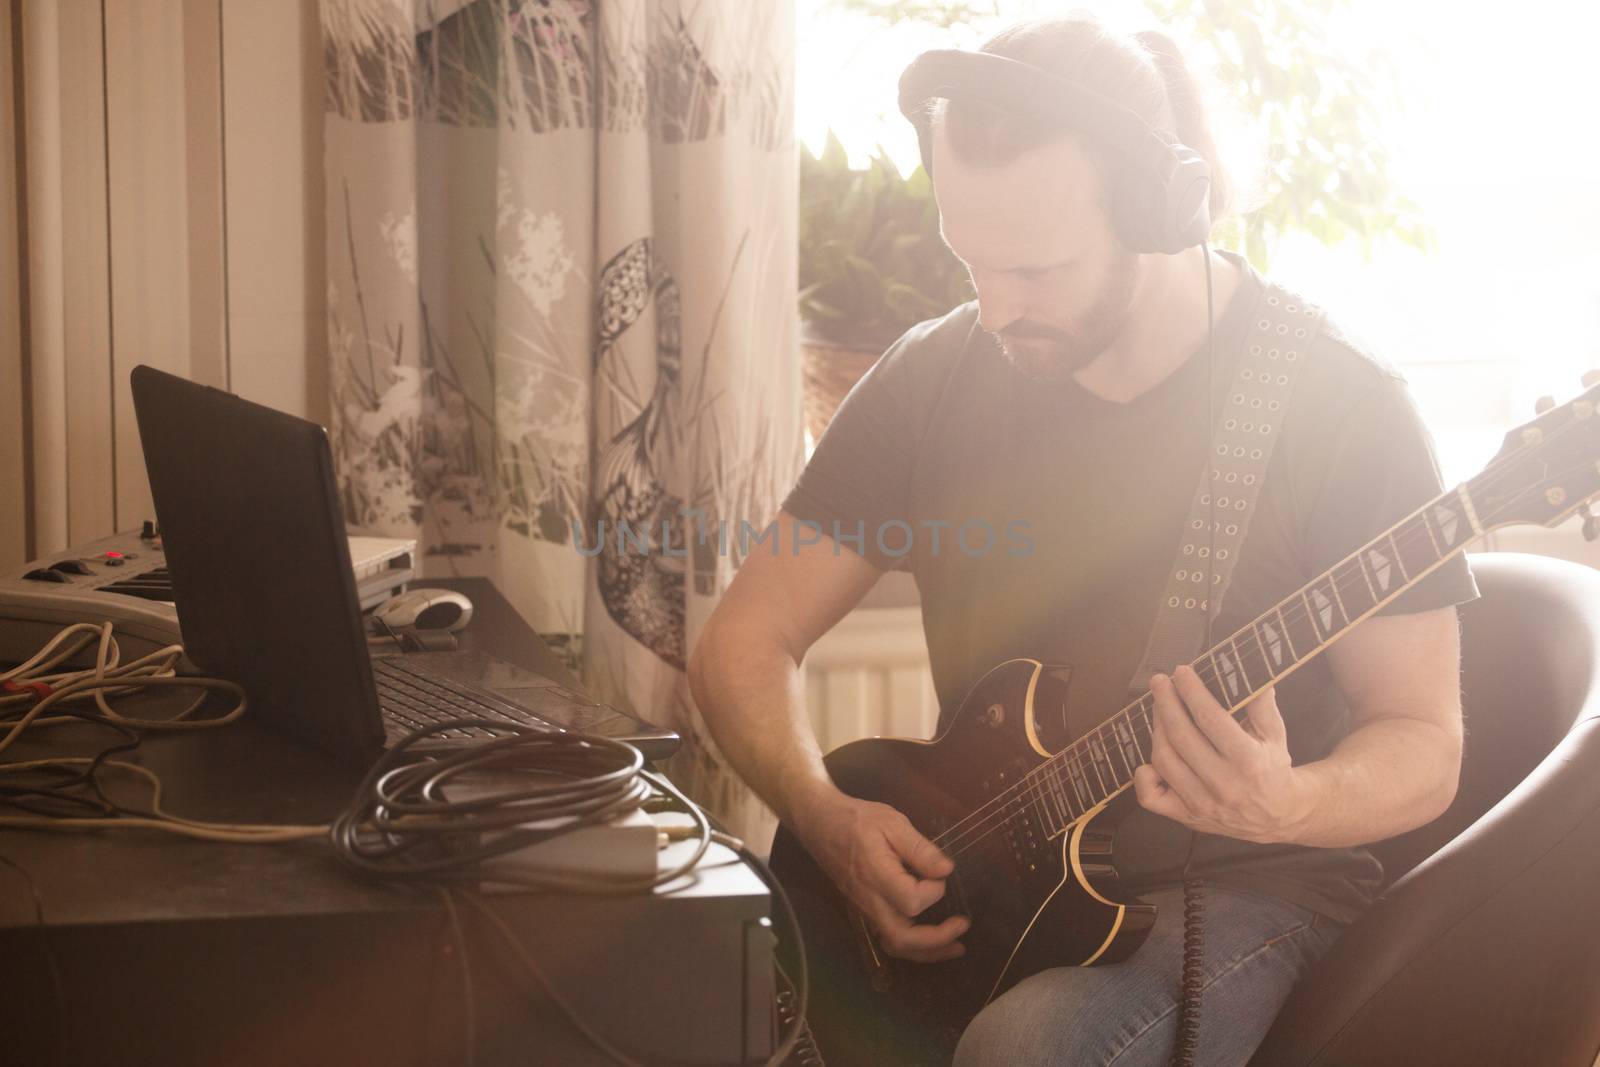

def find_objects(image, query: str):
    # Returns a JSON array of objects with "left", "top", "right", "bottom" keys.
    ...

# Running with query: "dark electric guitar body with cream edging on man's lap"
[{"left": 771, "top": 659, "right": 1155, "bottom": 1064}]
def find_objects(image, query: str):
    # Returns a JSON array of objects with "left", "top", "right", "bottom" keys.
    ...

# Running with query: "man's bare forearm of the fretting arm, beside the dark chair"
[{"left": 1283, "top": 717, "right": 1461, "bottom": 848}]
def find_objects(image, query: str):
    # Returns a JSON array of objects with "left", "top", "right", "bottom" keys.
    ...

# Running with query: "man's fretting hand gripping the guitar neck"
[{"left": 1133, "top": 665, "right": 1315, "bottom": 845}]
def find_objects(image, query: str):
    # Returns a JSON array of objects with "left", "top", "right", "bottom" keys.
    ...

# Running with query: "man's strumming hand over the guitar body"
[{"left": 794, "top": 790, "right": 970, "bottom": 963}]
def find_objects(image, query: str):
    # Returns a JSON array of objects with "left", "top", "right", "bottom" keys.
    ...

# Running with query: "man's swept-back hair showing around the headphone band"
[{"left": 933, "top": 13, "right": 1232, "bottom": 219}]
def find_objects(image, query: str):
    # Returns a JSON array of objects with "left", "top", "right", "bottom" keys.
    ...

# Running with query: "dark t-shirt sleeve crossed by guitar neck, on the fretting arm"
[{"left": 1306, "top": 373, "right": 1478, "bottom": 614}]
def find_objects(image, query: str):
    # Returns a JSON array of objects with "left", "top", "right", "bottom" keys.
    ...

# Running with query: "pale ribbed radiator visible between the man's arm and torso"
[{"left": 805, "top": 608, "right": 939, "bottom": 752}]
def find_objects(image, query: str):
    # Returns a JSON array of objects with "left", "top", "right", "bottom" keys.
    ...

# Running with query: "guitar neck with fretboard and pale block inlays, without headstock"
[{"left": 1030, "top": 483, "right": 1493, "bottom": 832}]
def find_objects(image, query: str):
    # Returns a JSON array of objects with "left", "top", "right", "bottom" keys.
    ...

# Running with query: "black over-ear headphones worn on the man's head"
[{"left": 899, "top": 48, "right": 1211, "bottom": 254}]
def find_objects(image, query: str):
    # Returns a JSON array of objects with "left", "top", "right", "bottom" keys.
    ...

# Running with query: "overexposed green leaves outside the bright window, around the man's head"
[{"left": 826, "top": 0, "right": 1434, "bottom": 269}]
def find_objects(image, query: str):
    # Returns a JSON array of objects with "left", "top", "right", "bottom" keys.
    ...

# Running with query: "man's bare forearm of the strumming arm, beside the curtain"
[{"left": 690, "top": 627, "right": 832, "bottom": 825}]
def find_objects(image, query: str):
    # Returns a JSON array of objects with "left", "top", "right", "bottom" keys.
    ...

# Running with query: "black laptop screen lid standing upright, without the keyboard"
[{"left": 131, "top": 366, "right": 384, "bottom": 763}]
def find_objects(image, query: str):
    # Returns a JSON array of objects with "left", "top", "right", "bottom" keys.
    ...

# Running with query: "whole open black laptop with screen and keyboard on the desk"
[{"left": 131, "top": 366, "right": 678, "bottom": 766}]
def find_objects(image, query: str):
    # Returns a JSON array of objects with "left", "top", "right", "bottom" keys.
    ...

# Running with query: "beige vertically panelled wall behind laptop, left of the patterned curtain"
[{"left": 0, "top": 0, "right": 326, "bottom": 569}]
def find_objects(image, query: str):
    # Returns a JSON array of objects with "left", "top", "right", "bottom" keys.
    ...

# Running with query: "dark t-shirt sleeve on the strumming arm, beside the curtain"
[{"left": 784, "top": 338, "right": 917, "bottom": 571}]
